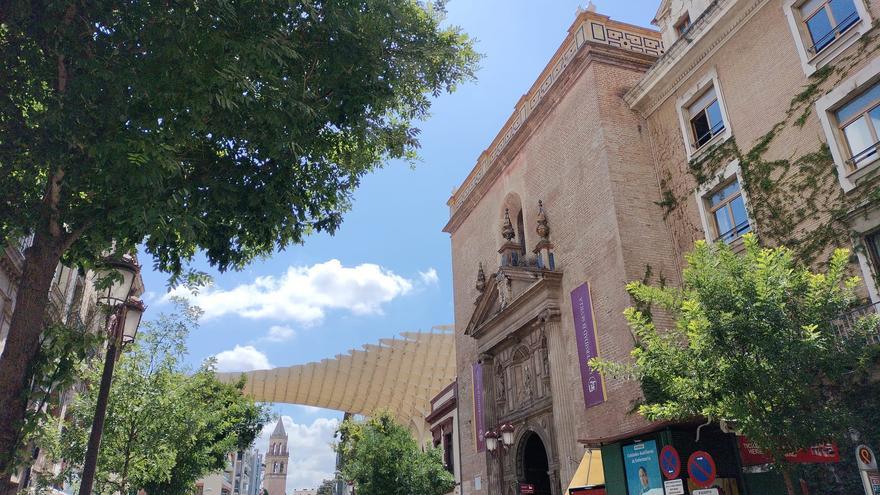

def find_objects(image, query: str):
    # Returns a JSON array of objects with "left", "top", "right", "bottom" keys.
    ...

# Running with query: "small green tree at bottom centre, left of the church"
[{"left": 336, "top": 411, "right": 455, "bottom": 495}]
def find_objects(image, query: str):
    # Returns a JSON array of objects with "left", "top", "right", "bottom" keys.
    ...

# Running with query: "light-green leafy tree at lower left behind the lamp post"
[{"left": 36, "top": 302, "right": 268, "bottom": 495}]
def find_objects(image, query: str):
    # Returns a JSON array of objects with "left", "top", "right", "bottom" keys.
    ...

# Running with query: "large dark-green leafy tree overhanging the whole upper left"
[{"left": 0, "top": 0, "right": 478, "bottom": 488}]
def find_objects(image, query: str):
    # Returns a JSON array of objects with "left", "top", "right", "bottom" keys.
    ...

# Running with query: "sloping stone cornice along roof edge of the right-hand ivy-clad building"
[{"left": 624, "top": 0, "right": 768, "bottom": 117}]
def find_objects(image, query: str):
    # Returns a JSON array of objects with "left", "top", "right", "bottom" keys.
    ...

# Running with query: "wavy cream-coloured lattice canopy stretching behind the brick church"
[{"left": 217, "top": 326, "right": 455, "bottom": 439}]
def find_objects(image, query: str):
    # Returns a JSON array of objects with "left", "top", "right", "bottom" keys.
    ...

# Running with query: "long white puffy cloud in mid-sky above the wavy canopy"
[{"left": 165, "top": 260, "right": 416, "bottom": 324}]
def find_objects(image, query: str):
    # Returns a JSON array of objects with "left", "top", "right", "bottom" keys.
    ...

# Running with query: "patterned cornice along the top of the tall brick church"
[{"left": 444, "top": 11, "right": 664, "bottom": 233}]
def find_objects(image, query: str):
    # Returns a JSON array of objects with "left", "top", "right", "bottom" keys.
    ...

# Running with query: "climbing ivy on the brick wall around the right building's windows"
[{"left": 657, "top": 23, "right": 880, "bottom": 274}]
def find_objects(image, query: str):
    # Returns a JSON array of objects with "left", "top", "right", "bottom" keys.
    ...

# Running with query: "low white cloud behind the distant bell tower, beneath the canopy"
[{"left": 256, "top": 416, "right": 339, "bottom": 493}]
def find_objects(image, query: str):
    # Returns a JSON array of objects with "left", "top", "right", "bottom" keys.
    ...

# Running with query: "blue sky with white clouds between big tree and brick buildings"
[{"left": 143, "top": 0, "right": 659, "bottom": 489}]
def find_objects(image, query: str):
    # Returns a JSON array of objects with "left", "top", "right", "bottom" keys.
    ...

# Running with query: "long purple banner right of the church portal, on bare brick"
[{"left": 571, "top": 283, "right": 605, "bottom": 407}]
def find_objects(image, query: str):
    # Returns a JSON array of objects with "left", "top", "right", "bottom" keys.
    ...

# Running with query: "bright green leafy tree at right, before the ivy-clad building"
[{"left": 591, "top": 235, "right": 878, "bottom": 495}]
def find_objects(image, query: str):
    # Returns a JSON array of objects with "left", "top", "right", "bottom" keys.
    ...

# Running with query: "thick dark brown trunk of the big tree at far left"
[{"left": 0, "top": 231, "right": 61, "bottom": 495}]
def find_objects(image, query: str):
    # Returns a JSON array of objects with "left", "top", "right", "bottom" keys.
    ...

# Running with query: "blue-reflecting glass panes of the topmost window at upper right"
[{"left": 798, "top": 0, "right": 859, "bottom": 55}]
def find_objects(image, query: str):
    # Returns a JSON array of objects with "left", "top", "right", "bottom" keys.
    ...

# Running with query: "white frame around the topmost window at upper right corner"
[{"left": 783, "top": 0, "right": 873, "bottom": 76}]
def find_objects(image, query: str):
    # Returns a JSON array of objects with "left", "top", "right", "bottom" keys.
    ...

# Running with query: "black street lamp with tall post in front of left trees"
[{"left": 79, "top": 258, "right": 146, "bottom": 495}]
